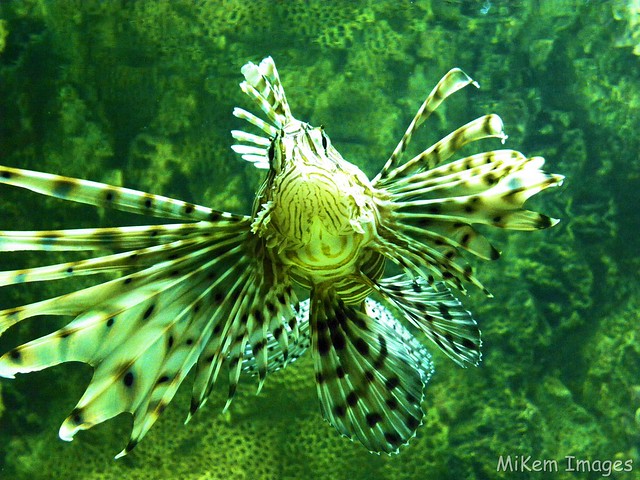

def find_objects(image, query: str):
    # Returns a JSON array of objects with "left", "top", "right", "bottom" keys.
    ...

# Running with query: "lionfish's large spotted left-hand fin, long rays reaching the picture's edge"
[{"left": 0, "top": 167, "right": 298, "bottom": 456}]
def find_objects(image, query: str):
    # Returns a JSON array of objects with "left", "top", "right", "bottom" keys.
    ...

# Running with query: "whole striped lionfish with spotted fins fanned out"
[{"left": 0, "top": 57, "right": 563, "bottom": 458}]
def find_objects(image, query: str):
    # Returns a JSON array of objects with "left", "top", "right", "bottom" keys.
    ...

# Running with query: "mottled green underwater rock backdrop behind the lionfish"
[{"left": 0, "top": 0, "right": 640, "bottom": 480}]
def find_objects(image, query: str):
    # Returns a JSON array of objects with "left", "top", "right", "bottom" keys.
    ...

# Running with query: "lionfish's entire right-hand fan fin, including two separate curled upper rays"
[{"left": 372, "top": 69, "right": 563, "bottom": 295}]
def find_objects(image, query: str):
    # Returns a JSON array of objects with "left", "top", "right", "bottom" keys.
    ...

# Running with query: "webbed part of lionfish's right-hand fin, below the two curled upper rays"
[{"left": 380, "top": 150, "right": 563, "bottom": 294}]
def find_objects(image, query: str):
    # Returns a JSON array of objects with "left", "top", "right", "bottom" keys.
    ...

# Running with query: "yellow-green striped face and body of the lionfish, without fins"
[{"left": 254, "top": 119, "right": 376, "bottom": 296}]
